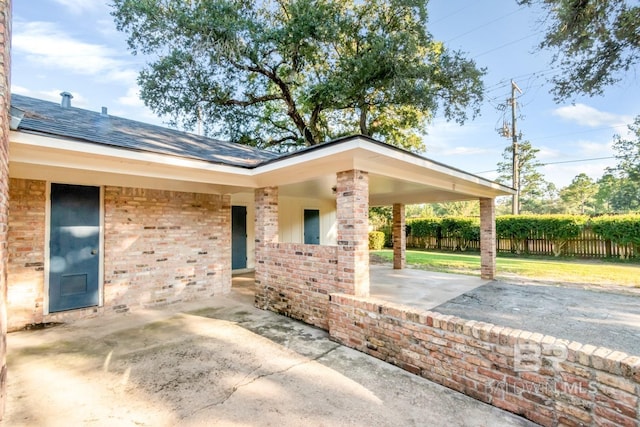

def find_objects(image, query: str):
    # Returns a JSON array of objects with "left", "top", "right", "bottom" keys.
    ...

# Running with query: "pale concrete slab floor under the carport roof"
[{"left": 369, "top": 264, "right": 490, "bottom": 310}]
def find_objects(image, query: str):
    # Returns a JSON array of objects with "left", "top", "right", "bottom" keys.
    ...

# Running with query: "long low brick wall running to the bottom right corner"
[{"left": 329, "top": 294, "right": 640, "bottom": 427}]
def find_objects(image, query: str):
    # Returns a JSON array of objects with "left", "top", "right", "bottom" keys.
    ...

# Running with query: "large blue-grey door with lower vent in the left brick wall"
[{"left": 49, "top": 184, "right": 100, "bottom": 312}]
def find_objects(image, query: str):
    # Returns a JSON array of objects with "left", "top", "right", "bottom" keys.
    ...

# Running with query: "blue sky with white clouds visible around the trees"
[{"left": 11, "top": 0, "right": 640, "bottom": 188}]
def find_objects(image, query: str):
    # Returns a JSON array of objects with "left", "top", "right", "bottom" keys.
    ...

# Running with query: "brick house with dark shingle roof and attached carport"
[{"left": 7, "top": 93, "right": 510, "bottom": 329}]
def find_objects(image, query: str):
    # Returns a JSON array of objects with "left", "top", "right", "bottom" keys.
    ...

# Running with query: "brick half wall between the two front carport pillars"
[{"left": 255, "top": 243, "right": 342, "bottom": 330}]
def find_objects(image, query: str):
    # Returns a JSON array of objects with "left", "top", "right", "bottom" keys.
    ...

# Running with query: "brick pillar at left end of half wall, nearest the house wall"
[{"left": 254, "top": 187, "right": 278, "bottom": 309}]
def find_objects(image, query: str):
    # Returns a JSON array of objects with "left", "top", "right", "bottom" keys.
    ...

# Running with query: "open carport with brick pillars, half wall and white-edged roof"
[{"left": 254, "top": 136, "right": 513, "bottom": 330}]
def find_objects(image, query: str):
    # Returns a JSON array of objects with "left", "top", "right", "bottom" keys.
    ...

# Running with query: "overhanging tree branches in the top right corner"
[{"left": 517, "top": 0, "right": 640, "bottom": 100}]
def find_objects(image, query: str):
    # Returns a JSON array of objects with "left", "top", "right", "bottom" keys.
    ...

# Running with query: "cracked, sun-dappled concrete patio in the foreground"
[{"left": 4, "top": 279, "right": 534, "bottom": 427}]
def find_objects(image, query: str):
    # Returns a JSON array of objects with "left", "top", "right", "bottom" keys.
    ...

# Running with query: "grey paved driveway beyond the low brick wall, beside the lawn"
[{"left": 433, "top": 281, "right": 640, "bottom": 355}]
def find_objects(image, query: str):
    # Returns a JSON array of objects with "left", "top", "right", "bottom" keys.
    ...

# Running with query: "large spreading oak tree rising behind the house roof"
[{"left": 112, "top": 0, "right": 484, "bottom": 150}]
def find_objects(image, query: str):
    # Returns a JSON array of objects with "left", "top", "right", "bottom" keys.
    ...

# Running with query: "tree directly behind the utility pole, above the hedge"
[{"left": 497, "top": 141, "right": 550, "bottom": 213}]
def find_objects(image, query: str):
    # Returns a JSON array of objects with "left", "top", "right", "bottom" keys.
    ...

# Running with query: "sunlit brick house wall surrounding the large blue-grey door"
[{"left": 8, "top": 179, "right": 231, "bottom": 329}]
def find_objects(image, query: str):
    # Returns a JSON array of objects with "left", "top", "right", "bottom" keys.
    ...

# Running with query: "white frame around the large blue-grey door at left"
[{"left": 43, "top": 181, "right": 104, "bottom": 315}]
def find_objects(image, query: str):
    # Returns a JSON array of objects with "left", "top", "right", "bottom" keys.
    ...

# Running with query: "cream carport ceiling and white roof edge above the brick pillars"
[{"left": 256, "top": 137, "right": 513, "bottom": 206}]
